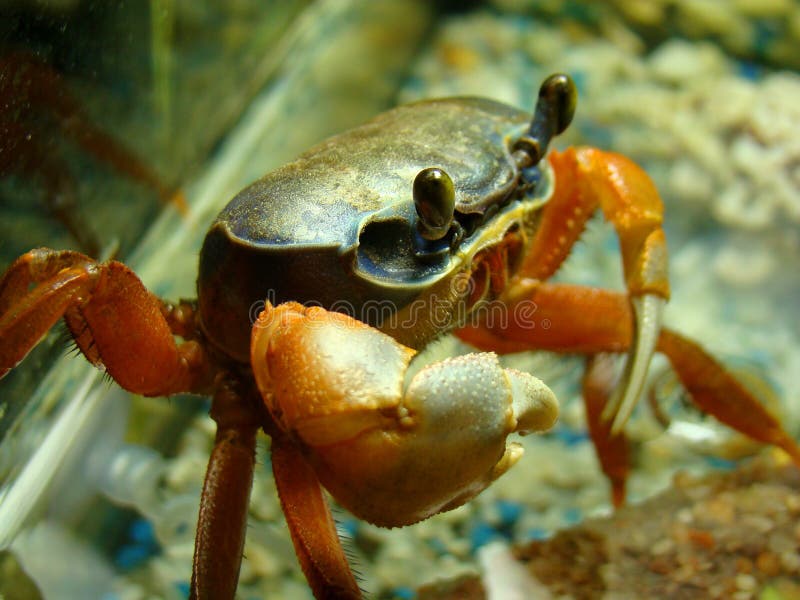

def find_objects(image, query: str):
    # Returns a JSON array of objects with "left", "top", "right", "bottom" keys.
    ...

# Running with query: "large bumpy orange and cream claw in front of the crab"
[{"left": 252, "top": 303, "right": 558, "bottom": 527}]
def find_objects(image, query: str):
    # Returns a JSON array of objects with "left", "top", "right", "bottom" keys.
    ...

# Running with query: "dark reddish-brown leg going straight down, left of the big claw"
[{"left": 189, "top": 382, "right": 262, "bottom": 600}]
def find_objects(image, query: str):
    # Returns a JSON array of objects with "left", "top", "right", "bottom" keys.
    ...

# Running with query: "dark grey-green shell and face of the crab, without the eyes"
[{"left": 198, "top": 98, "right": 551, "bottom": 363}]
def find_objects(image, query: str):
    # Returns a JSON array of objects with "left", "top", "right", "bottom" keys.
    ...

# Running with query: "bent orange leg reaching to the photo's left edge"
[{"left": 0, "top": 248, "right": 213, "bottom": 396}]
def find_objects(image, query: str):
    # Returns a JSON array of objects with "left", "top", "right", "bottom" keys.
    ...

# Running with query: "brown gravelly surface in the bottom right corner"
[{"left": 420, "top": 453, "right": 800, "bottom": 600}]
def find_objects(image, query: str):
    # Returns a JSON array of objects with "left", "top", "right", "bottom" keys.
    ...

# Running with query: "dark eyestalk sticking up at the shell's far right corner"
[{"left": 514, "top": 73, "right": 578, "bottom": 167}]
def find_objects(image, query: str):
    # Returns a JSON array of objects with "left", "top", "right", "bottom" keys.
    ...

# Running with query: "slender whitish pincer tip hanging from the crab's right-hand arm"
[{"left": 603, "top": 294, "right": 666, "bottom": 434}]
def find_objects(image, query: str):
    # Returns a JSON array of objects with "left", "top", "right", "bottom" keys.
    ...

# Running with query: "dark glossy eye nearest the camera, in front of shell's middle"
[{"left": 413, "top": 167, "right": 456, "bottom": 240}]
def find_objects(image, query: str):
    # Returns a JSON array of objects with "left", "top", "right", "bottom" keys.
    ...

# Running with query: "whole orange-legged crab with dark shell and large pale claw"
[{"left": 0, "top": 74, "right": 800, "bottom": 598}]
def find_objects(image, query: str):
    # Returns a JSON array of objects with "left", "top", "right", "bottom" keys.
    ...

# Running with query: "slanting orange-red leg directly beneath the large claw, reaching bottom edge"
[{"left": 272, "top": 432, "right": 361, "bottom": 599}]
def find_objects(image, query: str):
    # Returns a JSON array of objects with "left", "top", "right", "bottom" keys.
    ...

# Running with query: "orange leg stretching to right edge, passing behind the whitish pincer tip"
[{"left": 456, "top": 280, "right": 800, "bottom": 502}]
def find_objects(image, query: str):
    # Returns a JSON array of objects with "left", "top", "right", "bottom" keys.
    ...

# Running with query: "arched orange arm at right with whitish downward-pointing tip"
[{"left": 520, "top": 147, "right": 669, "bottom": 432}]
